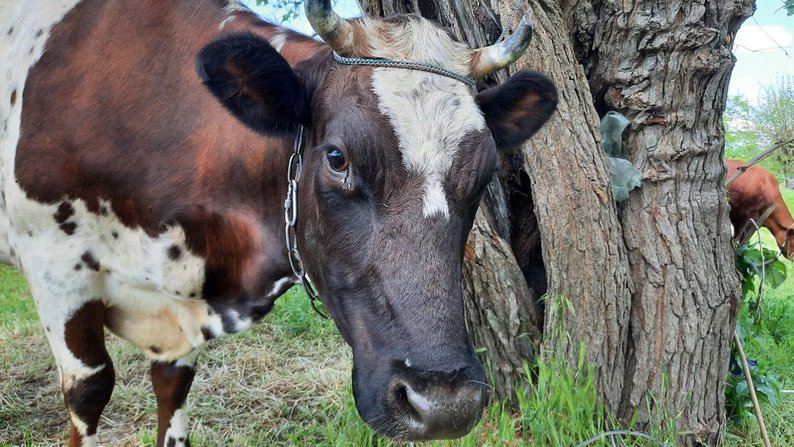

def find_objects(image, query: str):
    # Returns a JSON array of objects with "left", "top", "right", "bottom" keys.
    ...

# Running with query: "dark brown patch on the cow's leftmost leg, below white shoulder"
[{"left": 63, "top": 301, "right": 115, "bottom": 445}]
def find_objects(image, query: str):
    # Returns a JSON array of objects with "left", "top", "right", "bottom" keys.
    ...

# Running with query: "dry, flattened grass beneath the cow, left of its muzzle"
[{"left": 0, "top": 290, "right": 351, "bottom": 446}]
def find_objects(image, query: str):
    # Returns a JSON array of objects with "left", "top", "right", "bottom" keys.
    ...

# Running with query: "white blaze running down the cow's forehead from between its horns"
[{"left": 363, "top": 19, "right": 485, "bottom": 218}]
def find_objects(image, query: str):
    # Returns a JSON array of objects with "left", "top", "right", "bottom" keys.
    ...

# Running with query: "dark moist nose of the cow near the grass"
[{"left": 387, "top": 377, "right": 485, "bottom": 441}]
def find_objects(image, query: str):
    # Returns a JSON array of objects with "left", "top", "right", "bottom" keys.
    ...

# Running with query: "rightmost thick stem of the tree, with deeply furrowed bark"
[{"left": 562, "top": 0, "right": 754, "bottom": 445}]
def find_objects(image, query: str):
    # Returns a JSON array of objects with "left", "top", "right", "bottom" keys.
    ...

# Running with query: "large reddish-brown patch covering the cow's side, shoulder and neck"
[{"left": 12, "top": 0, "right": 310, "bottom": 308}]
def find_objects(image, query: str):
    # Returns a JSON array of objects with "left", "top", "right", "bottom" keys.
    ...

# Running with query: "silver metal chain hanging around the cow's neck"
[{"left": 284, "top": 126, "right": 331, "bottom": 318}]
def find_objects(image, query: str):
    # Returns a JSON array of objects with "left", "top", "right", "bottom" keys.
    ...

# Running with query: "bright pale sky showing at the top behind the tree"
[{"left": 244, "top": 0, "right": 794, "bottom": 103}]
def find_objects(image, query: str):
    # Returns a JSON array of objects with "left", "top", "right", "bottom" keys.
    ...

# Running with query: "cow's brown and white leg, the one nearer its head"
[{"left": 152, "top": 351, "right": 198, "bottom": 447}]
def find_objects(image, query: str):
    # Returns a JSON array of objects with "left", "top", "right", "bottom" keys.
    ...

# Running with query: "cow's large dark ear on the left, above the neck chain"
[{"left": 196, "top": 33, "right": 311, "bottom": 135}]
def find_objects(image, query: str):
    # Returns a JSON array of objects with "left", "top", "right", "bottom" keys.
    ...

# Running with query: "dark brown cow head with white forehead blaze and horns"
[{"left": 197, "top": 0, "right": 557, "bottom": 440}]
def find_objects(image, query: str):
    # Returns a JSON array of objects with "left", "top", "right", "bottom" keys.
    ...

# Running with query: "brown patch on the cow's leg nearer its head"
[{"left": 151, "top": 362, "right": 196, "bottom": 445}]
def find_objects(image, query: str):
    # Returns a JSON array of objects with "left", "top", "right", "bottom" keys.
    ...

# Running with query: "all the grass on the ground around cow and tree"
[{"left": 0, "top": 184, "right": 794, "bottom": 447}]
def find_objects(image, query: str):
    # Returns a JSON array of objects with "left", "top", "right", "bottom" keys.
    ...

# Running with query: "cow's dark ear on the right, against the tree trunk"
[{"left": 477, "top": 71, "right": 557, "bottom": 149}]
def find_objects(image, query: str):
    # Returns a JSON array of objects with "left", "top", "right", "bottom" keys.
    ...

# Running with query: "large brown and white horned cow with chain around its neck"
[{"left": 0, "top": 0, "right": 557, "bottom": 446}]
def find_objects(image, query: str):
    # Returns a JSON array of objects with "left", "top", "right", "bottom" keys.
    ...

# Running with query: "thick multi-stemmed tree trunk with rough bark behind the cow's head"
[{"left": 361, "top": 0, "right": 753, "bottom": 444}]
